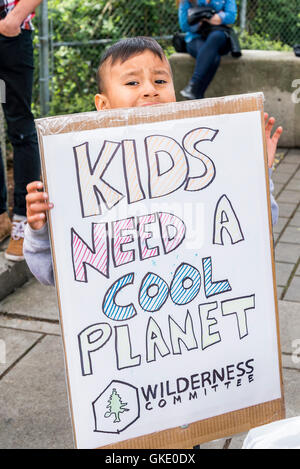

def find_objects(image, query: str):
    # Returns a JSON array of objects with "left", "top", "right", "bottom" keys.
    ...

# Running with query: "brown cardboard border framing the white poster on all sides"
[{"left": 35, "top": 93, "right": 285, "bottom": 449}]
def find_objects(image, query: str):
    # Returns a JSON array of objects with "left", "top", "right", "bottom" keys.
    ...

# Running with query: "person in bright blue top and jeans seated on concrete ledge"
[{"left": 178, "top": 0, "right": 237, "bottom": 99}]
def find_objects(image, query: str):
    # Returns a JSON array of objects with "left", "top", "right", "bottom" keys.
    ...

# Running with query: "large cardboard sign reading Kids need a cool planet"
[{"left": 37, "top": 94, "right": 284, "bottom": 448}]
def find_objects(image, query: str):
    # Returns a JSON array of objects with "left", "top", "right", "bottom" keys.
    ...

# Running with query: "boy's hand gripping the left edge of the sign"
[{"left": 26, "top": 181, "right": 53, "bottom": 230}]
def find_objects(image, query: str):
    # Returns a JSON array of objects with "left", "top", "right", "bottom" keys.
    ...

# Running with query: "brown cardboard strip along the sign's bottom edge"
[{"left": 98, "top": 399, "right": 284, "bottom": 449}]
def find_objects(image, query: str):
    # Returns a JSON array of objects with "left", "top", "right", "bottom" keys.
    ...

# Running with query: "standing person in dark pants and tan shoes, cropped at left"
[{"left": 0, "top": 0, "right": 42, "bottom": 261}]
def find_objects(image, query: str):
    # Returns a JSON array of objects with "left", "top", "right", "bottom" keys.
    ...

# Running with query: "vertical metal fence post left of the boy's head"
[{"left": 39, "top": 0, "right": 50, "bottom": 116}]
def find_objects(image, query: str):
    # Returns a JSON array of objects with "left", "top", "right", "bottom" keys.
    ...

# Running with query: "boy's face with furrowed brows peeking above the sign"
[{"left": 95, "top": 50, "right": 176, "bottom": 111}]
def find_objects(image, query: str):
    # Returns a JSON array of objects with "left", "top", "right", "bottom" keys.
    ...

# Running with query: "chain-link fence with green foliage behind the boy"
[{"left": 35, "top": 0, "right": 300, "bottom": 114}]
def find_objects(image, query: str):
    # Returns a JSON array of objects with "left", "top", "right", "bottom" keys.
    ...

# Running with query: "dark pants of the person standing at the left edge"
[{"left": 0, "top": 30, "right": 40, "bottom": 216}]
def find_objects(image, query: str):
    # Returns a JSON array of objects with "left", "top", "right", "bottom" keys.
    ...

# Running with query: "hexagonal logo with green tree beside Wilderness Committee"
[{"left": 92, "top": 380, "right": 140, "bottom": 433}]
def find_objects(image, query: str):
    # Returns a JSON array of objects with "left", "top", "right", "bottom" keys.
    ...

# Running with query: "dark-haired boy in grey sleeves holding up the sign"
[{"left": 24, "top": 37, "right": 282, "bottom": 285}]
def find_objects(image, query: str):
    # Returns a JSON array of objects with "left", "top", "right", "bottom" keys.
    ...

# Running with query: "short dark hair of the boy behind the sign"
[{"left": 97, "top": 36, "right": 165, "bottom": 93}]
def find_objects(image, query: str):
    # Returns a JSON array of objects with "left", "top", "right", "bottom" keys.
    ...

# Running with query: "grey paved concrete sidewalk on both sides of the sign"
[{"left": 0, "top": 150, "right": 300, "bottom": 449}]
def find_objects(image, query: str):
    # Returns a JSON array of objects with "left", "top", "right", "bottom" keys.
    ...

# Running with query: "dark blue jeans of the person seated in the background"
[{"left": 186, "top": 31, "right": 230, "bottom": 98}]
